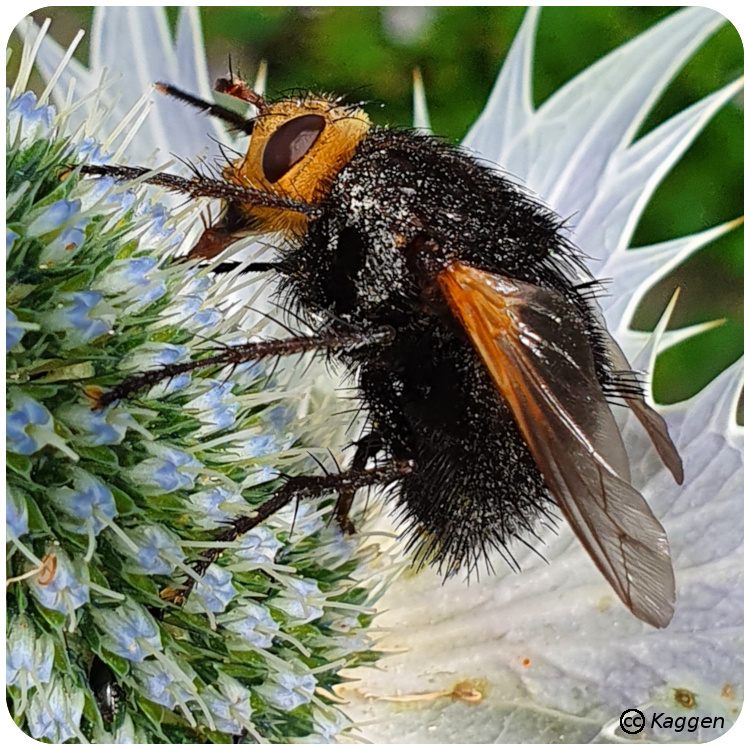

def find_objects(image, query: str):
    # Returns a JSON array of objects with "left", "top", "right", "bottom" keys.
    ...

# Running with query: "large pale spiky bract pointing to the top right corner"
[{"left": 485, "top": 8, "right": 724, "bottom": 223}]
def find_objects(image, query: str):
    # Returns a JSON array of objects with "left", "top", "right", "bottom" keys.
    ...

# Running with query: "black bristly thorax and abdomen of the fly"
[{"left": 282, "top": 130, "right": 609, "bottom": 575}]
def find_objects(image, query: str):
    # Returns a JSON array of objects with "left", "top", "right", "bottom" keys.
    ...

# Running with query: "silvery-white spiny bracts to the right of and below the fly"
[{"left": 343, "top": 8, "right": 744, "bottom": 743}]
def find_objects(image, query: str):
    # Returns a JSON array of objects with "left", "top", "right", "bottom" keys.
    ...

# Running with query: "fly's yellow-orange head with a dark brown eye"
[{"left": 224, "top": 96, "right": 371, "bottom": 234}]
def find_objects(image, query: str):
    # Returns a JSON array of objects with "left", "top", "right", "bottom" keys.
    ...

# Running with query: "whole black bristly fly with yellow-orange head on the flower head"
[{"left": 81, "top": 79, "right": 682, "bottom": 627}]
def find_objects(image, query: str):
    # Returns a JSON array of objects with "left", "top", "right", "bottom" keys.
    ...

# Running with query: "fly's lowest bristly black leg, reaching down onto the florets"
[{"left": 161, "top": 461, "right": 412, "bottom": 605}]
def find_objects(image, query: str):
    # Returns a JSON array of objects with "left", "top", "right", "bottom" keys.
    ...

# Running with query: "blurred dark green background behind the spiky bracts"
[{"left": 10, "top": 7, "right": 743, "bottom": 412}]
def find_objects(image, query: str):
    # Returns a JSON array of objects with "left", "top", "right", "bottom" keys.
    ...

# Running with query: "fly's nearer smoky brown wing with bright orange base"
[{"left": 437, "top": 262, "right": 675, "bottom": 627}]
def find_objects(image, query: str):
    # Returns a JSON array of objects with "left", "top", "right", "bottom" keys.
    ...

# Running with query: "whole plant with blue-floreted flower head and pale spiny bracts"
[{"left": 6, "top": 8, "right": 743, "bottom": 742}]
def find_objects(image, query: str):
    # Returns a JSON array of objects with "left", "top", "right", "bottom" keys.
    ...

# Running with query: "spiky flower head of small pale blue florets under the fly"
[{"left": 6, "top": 14, "right": 378, "bottom": 742}]
